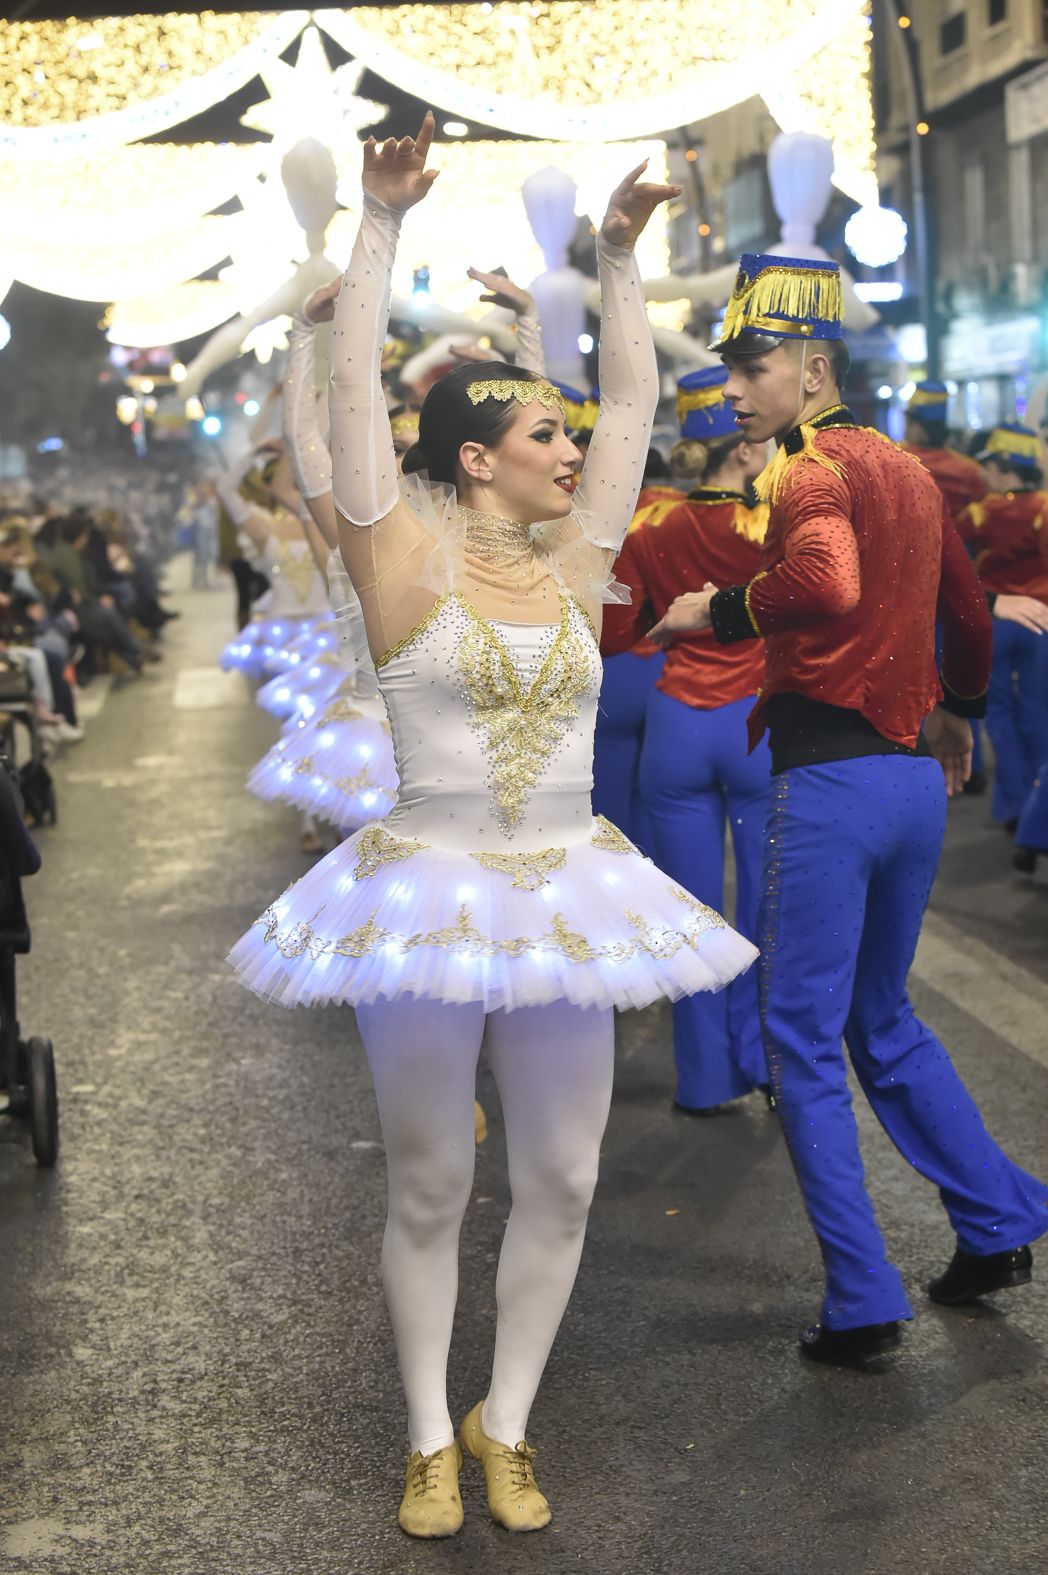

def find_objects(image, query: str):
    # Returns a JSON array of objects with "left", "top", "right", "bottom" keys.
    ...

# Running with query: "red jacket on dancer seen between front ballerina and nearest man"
[{"left": 600, "top": 488, "right": 767, "bottom": 710}]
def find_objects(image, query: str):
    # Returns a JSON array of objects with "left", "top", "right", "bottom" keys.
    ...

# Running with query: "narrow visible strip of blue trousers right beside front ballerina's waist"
[{"left": 593, "top": 650, "right": 665, "bottom": 854}]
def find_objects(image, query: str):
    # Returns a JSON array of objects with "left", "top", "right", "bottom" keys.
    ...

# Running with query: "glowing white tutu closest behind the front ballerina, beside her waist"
[{"left": 247, "top": 693, "right": 397, "bottom": 835}]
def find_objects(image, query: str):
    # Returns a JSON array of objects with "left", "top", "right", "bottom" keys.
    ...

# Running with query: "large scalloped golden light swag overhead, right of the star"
[{"left": 315, "top": 0, "right": 875, "bottom": 200}]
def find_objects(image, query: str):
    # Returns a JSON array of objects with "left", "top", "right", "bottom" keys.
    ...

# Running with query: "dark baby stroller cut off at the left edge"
[{"left": 0, "top": 756, "right": 58, "bottom": 1166}]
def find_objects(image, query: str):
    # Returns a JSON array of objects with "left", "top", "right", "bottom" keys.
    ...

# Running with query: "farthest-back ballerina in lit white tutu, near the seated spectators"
[{"left": 217, "top": 450, "right": 328, "bottom": 679}]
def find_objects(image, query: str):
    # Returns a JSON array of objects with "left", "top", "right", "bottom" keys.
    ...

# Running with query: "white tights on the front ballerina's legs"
[{"left": 356, "top": 999, "right": 615, "bottom": 1454}]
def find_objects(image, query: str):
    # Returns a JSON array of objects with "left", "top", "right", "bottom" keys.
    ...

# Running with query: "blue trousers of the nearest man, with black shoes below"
[{"left": 758, "top": 756, "right": 1048, "bottom": 1329}]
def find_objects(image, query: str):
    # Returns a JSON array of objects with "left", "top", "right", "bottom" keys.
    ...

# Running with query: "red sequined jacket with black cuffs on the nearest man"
[{"left": 711, "top": 405, "right": 991, "bottom": 748}]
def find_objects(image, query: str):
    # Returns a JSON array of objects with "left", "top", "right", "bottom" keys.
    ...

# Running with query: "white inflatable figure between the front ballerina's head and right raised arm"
[{"left": 520, "top": 167, "right": 589, "bottom": 387}]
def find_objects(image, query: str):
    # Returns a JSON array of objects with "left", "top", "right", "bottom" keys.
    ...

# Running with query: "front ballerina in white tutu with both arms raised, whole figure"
[{"left": 232, "top": 115, "right": 756, "bottom": 1537}]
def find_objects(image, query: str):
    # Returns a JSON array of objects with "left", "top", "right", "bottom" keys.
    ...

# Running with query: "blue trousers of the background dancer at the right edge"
[{"left": 987, "top": 619, "right": 1048, "bottom": 821}]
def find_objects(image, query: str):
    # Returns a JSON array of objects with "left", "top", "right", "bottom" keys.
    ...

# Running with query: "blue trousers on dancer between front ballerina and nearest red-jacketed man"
[{"left": 640, "top": 690, "right": 771, "bottom": 1109}]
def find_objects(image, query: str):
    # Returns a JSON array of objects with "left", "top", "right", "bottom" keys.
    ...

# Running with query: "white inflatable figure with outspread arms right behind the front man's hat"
[{"left": 633, "top": 131, "right": 879, "bottom": 364}]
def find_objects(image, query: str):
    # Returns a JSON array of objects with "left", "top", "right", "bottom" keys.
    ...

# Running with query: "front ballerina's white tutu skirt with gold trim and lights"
[{"left": 229, "top": 819, "right": 756, "bottom": 1011}]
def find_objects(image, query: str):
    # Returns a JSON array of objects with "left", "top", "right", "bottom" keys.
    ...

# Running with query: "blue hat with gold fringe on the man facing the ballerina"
[{"left": 709, "top": 252, "right": 843, "bottom": 354}]
